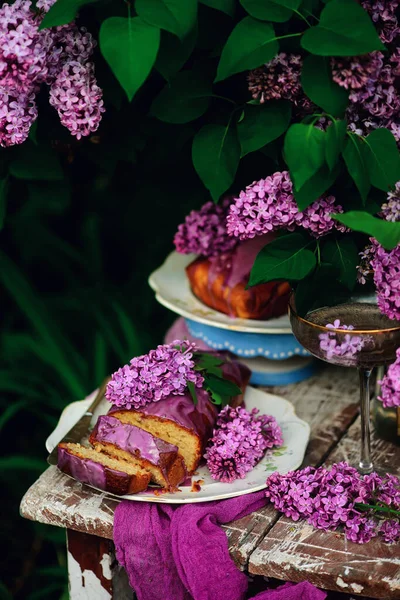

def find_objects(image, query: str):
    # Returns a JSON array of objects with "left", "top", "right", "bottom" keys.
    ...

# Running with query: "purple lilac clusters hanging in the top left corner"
[{"left": 0, "top": 0, "right": 104, "bottom": 147}]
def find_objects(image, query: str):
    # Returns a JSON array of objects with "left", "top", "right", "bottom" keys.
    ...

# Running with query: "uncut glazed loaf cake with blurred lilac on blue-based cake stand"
[{"left": 174, "top": 199, "right": 290, "bottom": 320}]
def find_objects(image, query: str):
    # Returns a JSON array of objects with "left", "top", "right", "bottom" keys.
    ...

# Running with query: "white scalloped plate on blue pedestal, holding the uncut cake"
[{"left": 149, "top": 252, "right": 292, "bottom": 334}]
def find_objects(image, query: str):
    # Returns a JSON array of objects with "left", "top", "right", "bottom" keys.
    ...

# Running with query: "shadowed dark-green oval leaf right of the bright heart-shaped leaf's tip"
[{"left": 150, "top": 69, "right": 212, "bottom": 123}]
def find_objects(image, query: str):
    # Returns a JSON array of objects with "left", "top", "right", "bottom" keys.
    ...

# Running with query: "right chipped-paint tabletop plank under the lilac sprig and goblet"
[{"left": 249, "top": 419, "right": 400, "bottom": 600}]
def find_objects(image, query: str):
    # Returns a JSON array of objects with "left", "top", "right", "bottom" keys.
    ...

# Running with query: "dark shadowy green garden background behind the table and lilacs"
[{"left": 0, "top": 2, "right": 271, "bottom": 600}]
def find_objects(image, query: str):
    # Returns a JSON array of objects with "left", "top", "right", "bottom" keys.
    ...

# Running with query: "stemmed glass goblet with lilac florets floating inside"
[{"left": 289, "top": 294, "right": 400, "bottom": 474}]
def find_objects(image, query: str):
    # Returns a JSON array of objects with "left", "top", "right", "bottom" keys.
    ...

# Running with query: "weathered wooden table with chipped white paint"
[{"left": 21, "top": 367, "right": 400, "bottom": 600}]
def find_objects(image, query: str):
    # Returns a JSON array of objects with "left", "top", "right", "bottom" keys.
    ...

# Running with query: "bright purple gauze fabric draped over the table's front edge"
[{"left": 114, "top": 491, "right": 326, "bottom": 600}]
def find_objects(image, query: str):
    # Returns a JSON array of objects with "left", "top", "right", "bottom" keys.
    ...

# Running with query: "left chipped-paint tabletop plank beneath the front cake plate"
[{"left": 21, "top": 367, "right": 358, "bottom": 569}]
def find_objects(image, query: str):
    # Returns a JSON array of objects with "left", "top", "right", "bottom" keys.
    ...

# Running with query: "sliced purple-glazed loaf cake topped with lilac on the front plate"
[{"left": 58, "top": 340, "right": 251, "bottom": 495}]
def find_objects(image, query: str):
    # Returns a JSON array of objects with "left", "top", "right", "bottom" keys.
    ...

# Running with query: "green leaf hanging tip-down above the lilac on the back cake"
[{"left": 192, "top": 125, "right": 240, "bottom": 202}]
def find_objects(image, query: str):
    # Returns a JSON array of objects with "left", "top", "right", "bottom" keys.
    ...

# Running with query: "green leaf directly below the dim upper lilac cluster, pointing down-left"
[{"left": 238, "top": 100, "right": 292, "bottom": 156}]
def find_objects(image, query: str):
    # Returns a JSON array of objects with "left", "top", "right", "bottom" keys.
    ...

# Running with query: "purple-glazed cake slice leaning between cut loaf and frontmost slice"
[{"left": 90, "top": 415, "right": 187, "bottom": 490}]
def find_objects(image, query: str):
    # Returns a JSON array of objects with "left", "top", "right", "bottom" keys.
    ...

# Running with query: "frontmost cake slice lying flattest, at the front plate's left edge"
[{"left": 58, "top": 443, "right": 150, "bottom": 496}]
